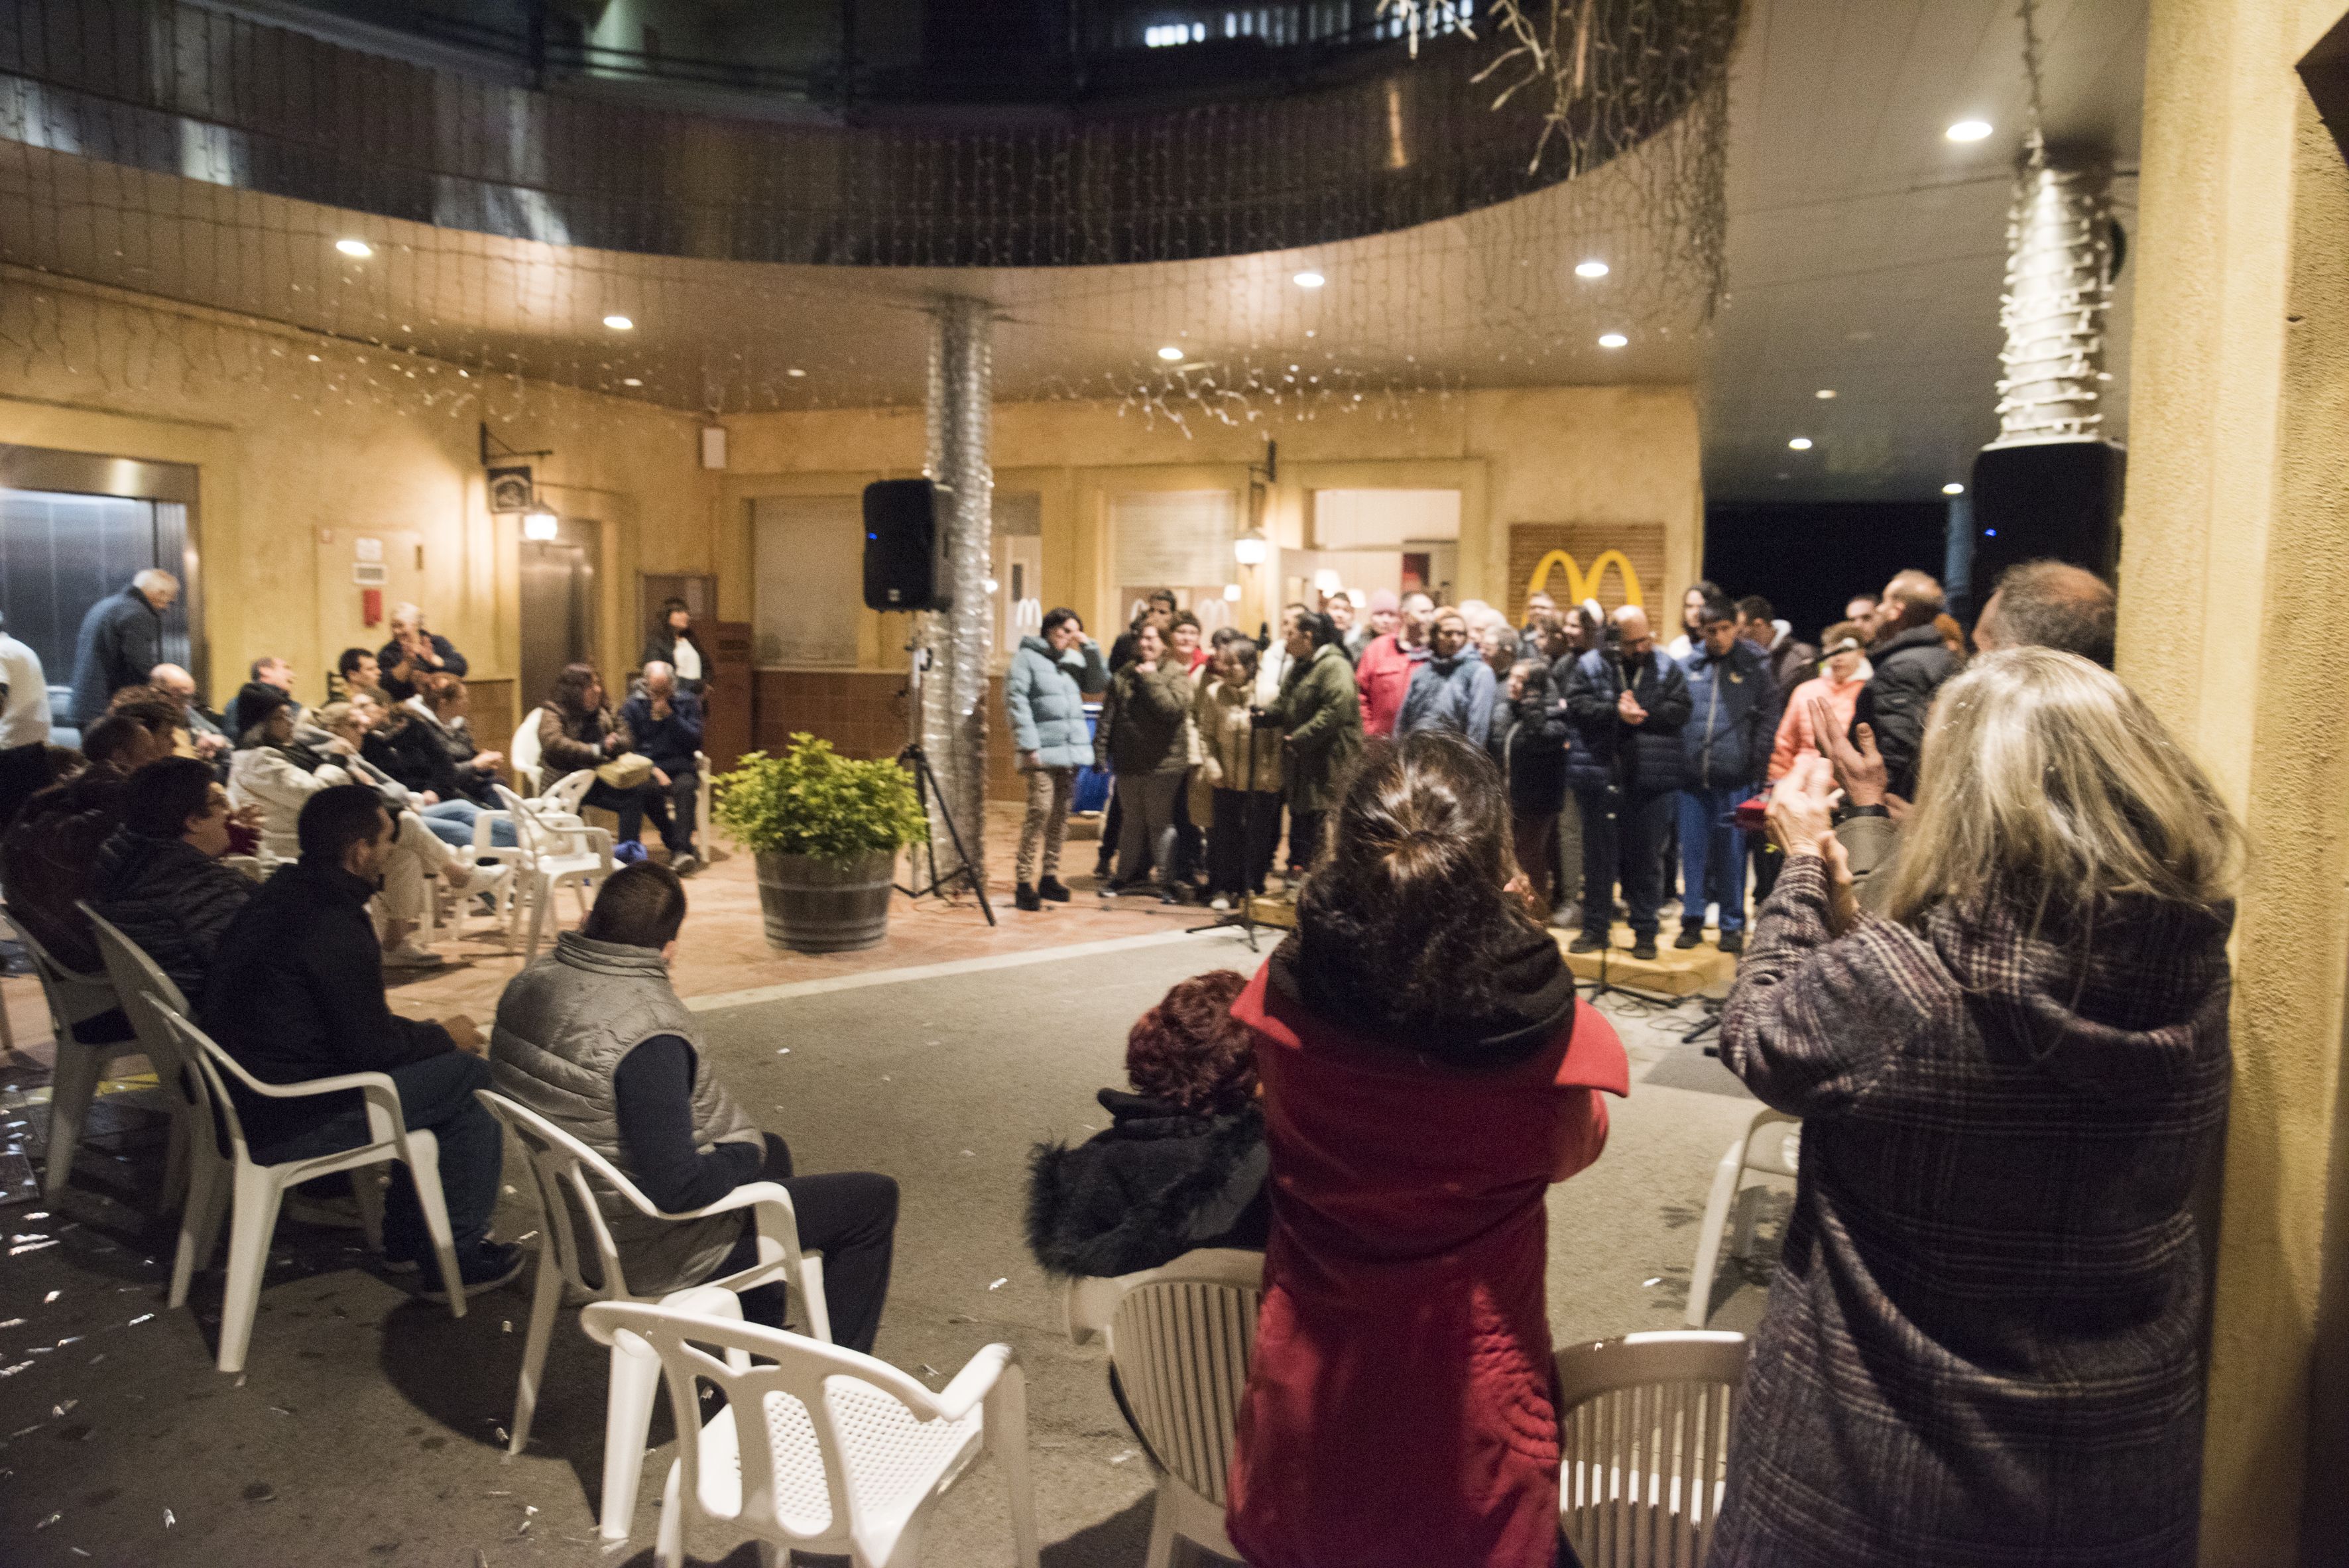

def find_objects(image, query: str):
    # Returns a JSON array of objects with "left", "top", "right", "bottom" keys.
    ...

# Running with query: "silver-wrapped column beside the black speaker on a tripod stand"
[{"left": 921, "top": 298, "right": 996, "bottom": 878}]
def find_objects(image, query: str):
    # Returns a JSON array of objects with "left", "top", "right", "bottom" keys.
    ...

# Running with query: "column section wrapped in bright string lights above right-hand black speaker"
[{"left": 1992, "top": 148, "right": 2112, "bottom": 446}]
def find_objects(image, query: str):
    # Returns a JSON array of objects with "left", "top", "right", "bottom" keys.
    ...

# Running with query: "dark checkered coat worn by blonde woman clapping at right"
[{"left": 1710, "top": 857, "right": 2232, "bottom": 1568}]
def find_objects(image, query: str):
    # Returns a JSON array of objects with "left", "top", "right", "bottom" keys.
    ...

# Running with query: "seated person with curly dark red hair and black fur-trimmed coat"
[{"left": 1026, "top": 969, "right": 1271, "bottom": 1274}]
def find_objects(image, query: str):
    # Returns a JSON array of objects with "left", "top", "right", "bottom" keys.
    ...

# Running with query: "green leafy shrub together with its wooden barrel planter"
[{"left": 709, "top": 735, "right": 930, "bottom": 953}]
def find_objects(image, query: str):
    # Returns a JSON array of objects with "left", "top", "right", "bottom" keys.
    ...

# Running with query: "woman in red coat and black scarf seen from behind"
[{"left": 1229, "top": 733, "right": 1630, "bottom": 1568}]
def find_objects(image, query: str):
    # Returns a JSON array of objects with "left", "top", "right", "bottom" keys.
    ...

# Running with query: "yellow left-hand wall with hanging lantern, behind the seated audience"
[{"left": 0, "top": 270, "right": 714, "bottom": 702}]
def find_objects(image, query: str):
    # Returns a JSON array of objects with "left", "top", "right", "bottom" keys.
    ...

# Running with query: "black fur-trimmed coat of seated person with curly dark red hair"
[{"left": 1029, "top": 1089, "right": 1271, "bottom": 1274}]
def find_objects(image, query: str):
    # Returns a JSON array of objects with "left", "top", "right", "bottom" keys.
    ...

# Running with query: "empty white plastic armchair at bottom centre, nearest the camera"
[{"left": 583, "top": 1291, "right": 1038, "bottom": 1568}]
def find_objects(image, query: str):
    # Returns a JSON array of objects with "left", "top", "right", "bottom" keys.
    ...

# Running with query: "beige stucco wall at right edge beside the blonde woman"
[{"left": 2121, "top": 0, "right": 2349, "bottom": 1565}]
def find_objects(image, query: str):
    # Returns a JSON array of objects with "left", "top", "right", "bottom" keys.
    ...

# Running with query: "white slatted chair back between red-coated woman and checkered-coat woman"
[{"left": 1557, "top": 1329, "right": 1750, "bottom": 1568}]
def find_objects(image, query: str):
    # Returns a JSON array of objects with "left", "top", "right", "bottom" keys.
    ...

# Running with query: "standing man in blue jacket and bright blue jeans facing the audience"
[{"left": 1673, "top": 599, "right": 1785, "bottom": 953}]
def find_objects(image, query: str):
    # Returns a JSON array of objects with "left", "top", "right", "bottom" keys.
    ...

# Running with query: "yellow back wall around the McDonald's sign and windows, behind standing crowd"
[{"left": 717, "top": 387, "right": 1703, "bottom": 669}]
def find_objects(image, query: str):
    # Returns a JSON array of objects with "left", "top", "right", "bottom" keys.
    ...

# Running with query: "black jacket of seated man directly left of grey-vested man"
[{"left": 202, "top": 857, "right": 455, "bottom": 1148}]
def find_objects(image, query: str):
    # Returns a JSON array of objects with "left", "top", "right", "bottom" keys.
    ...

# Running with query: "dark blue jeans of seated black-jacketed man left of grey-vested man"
[{"left": 254, "top": 1052, "right": 505, "bottom": 1263}]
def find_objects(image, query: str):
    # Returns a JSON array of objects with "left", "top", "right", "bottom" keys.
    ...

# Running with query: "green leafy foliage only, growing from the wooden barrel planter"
[{"left": 709, "top": 735, "right": 930, "bottom": 861}]
